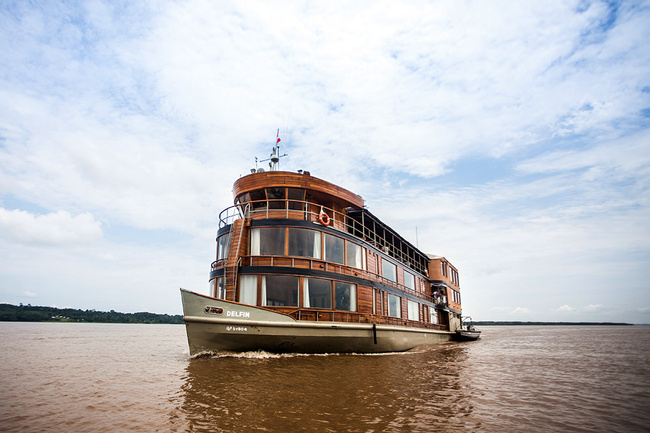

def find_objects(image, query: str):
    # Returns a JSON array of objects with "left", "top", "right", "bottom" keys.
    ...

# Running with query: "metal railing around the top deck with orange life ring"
[{"left": 219, "top": 199, "right": 427, "bottom": 275}]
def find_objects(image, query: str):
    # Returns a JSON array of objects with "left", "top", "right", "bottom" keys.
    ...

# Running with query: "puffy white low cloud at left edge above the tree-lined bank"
[{"left": 0, "top": 208, "right": 102, "bottom": 245}]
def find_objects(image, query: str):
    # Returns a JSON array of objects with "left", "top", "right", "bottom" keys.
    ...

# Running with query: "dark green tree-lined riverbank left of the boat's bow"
[{"left": 0, "top": 304, "right": 183, "bottom": 324}]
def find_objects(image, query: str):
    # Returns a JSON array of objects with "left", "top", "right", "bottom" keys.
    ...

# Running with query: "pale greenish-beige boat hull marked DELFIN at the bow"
[{"left": 181, "top": 289, "right": 454, "bottom": 356}]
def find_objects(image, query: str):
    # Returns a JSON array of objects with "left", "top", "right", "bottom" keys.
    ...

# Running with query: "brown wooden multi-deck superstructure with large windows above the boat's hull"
[{"left": 210, "top": 171, "right": 461, "bottom": 330}]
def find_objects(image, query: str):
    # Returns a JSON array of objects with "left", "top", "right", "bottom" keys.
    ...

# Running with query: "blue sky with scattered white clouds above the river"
[{"left": 0, "top": 0, "right": 650, "bottom": 323}]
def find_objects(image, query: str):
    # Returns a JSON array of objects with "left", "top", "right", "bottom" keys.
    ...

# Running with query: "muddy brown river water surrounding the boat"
[{"left": 0, "top": 322, "right": 650, "bottom": 432}]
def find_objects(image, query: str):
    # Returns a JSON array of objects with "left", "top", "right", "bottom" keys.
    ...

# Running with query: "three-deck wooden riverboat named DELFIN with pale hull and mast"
[{"left": 181, "top": 143, "right": 461, "bottom": 356}]
